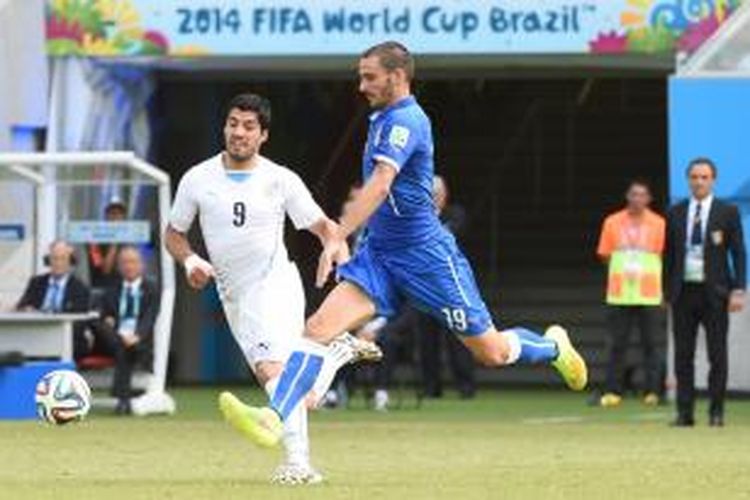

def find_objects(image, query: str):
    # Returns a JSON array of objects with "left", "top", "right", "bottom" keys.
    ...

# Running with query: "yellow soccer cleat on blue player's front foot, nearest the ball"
[{"left": 219, "top": 392, "right": 283, "bottom": 448}]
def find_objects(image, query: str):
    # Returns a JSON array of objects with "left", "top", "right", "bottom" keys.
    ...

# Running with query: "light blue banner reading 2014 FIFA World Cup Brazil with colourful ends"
[{"left": 47, "top": 0, "right": 742, "bottom": 57}]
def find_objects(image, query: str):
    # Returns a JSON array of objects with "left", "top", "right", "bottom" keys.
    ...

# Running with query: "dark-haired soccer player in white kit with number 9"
[{"left": 165, "top": 94, "right": 380, "bottom": 484}]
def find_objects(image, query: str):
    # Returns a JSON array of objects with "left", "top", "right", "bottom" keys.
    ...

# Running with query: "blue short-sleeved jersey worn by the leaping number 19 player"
[{"left": 362, "top": 96, "right": 444, "bottom": 250}]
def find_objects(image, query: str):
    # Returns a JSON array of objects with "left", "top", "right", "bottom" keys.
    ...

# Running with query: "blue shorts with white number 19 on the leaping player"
[{"left": 338, "top": 235, "right": 492, "bottom": 336}]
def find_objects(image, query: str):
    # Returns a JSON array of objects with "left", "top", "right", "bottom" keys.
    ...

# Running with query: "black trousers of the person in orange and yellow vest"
[{"left": 606, "top": 306, "right": 664, "bottom": 394}]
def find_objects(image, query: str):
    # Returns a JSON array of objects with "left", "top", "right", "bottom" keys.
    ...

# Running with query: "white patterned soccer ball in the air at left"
[{"left": 35, "top": 370, "right": 91, "bottom": 425}]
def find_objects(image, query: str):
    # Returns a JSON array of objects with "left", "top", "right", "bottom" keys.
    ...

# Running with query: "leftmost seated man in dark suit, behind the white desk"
[{"left": 16, "top": 241, "right": 91, "bottom": 359}]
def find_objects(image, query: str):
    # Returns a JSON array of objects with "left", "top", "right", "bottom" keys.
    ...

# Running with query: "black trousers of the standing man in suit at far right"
[{"left": 672, "top": 283, "right": 729, "bottom": 418}]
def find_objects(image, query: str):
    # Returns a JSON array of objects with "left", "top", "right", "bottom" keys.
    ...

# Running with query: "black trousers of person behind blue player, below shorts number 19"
[{"left": 418, "top": 314, "right": 476, "bottom": 397}]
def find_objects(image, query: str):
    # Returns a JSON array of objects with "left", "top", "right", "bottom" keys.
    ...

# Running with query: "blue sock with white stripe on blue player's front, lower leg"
[{"left": 271, "top": 351, "right": 323, "bottom": 420}]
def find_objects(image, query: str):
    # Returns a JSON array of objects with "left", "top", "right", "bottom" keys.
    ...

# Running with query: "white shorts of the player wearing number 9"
[{"left": 222, "top": 262, "right": 305, "bottom": 369}]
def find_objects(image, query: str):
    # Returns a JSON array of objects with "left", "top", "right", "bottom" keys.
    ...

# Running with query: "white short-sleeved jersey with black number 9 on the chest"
[{"left": 169, "top": 153, "right": 325, "bottom": 299}]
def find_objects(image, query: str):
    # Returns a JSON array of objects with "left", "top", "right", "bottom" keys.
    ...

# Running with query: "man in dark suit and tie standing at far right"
[{"left": 665, "top": 158, "right": 746, "bottom": 427}]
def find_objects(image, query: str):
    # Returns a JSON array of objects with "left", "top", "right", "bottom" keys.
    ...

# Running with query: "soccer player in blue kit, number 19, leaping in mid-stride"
[{"left": 219, "top": 42, "right": 588, "bottom": 446}]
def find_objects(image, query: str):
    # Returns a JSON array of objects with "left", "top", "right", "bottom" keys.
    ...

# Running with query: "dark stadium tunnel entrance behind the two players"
[{"left": 152, "top": 67, "right": 668, "bottom": 384}]
